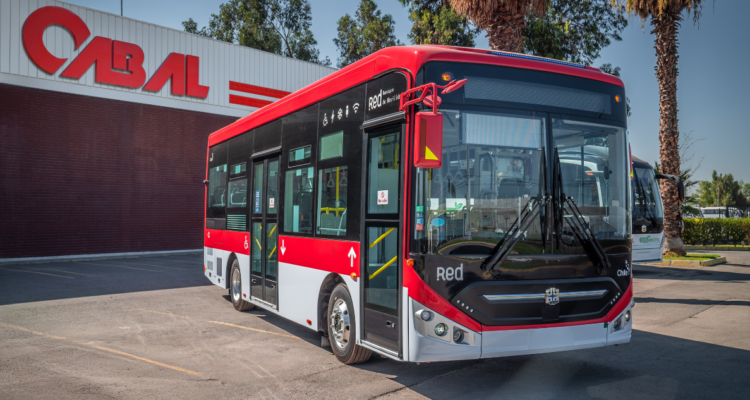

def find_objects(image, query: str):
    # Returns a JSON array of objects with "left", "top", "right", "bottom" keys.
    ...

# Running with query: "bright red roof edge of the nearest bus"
[{"left": 208, "top": 45, "right": 624, "bottom": 146}]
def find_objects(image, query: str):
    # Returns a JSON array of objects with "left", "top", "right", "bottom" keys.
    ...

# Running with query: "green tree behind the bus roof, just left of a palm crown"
[{"left": 398, "top": 0, "right": 479, "bottom": 47}]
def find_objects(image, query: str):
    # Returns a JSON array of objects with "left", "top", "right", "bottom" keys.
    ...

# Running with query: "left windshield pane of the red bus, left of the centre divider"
[{"left": 415, "top": 110, "right": 545, "bottom": 255}]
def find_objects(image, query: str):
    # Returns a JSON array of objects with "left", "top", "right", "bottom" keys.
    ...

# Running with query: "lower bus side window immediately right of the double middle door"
[{"left": 284, "top": 167, "right": 314, "bottom": 233}]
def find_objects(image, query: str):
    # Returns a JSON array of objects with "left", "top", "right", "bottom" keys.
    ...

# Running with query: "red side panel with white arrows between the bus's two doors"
[{"left": 276, "top": 236, "right": 360, "bottom": 276}]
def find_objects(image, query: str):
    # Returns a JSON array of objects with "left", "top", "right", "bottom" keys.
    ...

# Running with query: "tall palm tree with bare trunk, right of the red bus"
[{"left": 612, "top": 0, "right": 702, "bottom": 255}]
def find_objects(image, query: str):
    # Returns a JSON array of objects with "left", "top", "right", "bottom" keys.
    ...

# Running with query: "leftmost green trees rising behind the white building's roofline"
[{"left": 182, "top": 0, "right": 331, "bottom": 65}]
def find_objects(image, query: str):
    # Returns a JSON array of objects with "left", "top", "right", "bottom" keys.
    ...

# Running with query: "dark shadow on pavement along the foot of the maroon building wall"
[{"left": 0, "top": 253, "right": 210, "bottom": 305}]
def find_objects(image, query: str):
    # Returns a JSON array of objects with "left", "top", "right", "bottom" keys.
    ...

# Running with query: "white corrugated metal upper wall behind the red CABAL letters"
[{"left": 0, "top": 0, "right": 335, "bottom": 114}]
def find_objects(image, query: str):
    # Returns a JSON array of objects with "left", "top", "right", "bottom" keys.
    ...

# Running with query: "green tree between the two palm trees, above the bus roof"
[{"left": 524, "top": 0, "right": 628, "bottom": 65}]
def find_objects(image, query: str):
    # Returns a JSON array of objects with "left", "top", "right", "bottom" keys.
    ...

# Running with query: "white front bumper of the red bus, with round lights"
[{"left": 408, "top": 299, "right": 633, "bottom": 362}]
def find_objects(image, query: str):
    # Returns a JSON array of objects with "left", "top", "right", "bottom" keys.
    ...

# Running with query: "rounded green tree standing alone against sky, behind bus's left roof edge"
[{"left": 333, "top": 0, "right": 402, "bottom": 68}]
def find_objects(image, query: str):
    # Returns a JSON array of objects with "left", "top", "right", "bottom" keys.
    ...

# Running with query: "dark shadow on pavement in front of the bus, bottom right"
[{"left": 355, "top": 331, "right": 750, "bottom": 399}]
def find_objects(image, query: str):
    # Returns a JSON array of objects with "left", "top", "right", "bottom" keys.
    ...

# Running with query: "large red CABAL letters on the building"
[{"left": 22, "top": 6, "right": 209, "bottom": 99}]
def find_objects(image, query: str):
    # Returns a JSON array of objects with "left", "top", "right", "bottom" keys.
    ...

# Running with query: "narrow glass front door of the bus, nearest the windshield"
[{"left": 360, "top": 124, "right": 404, "bottom": 355}]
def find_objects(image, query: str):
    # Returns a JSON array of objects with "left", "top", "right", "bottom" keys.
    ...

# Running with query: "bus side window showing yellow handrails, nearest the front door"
[{"left": 317, "top": 167, "right": 349, "bottom": 236}]
